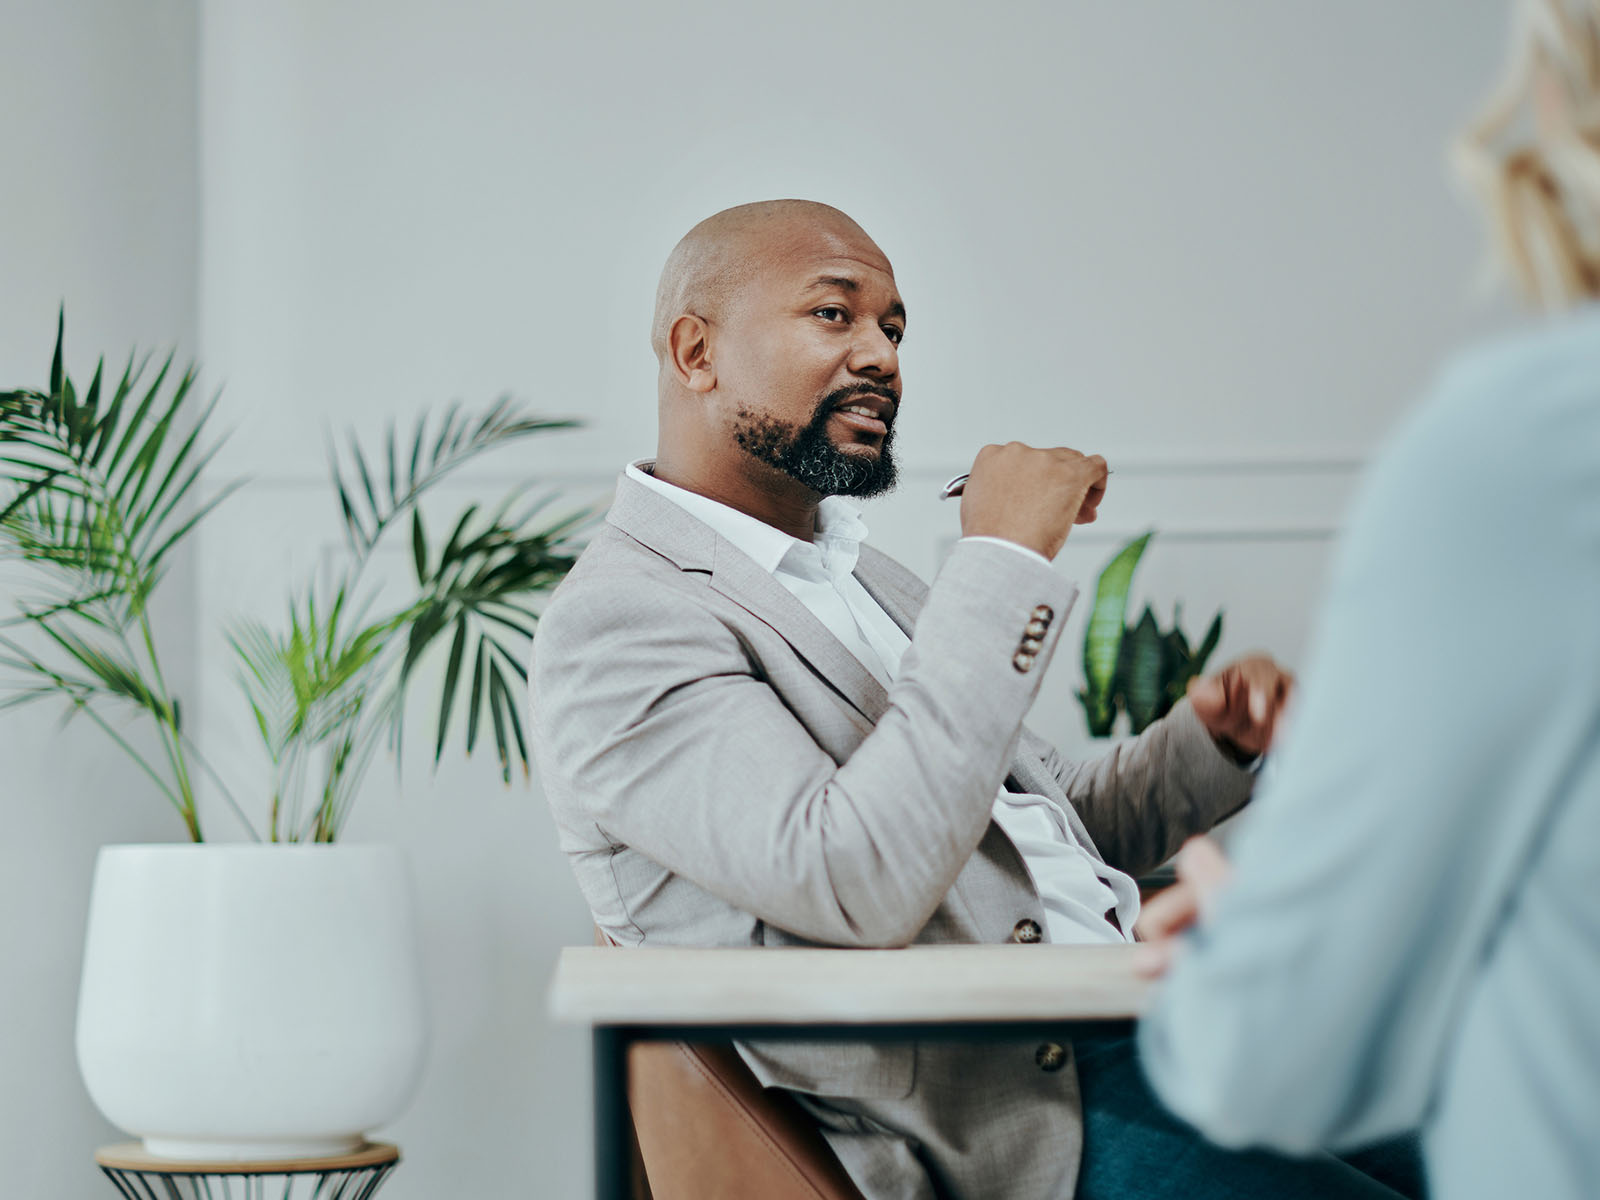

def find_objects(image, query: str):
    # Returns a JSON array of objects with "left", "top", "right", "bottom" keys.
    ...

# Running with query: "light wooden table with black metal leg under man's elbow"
[{"left": 549, "top": 946, "right": 1149, "bottom": 1200}]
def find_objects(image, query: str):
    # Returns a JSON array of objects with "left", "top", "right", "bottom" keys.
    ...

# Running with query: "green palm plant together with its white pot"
[{"left": 0, "top": 315, "right": 587, "bottom": 1160}]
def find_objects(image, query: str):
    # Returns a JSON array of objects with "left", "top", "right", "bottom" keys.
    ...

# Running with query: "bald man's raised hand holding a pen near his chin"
[{"left": 962, "top": 442, "right": 1106, "bottom": 558}]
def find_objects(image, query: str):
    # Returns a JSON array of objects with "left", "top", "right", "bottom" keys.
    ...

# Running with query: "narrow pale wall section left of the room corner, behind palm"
[{"left": 0, "top": 0, "right": 198, "bottom": 1200}]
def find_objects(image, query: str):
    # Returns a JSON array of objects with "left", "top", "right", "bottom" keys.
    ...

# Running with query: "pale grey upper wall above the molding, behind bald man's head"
[{"left": 190, "top": 0, "right": 1502, "bottom": 474}]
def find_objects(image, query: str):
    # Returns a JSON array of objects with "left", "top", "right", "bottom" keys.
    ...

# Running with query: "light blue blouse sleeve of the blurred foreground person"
[{"left": 1141, "top": 360, "right": 1600, "bottom": 1152}]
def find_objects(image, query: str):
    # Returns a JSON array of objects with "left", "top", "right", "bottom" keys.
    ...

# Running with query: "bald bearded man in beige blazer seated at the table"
[{"left": 531, "top": 200, "right": 1392, "bottom": 1200}]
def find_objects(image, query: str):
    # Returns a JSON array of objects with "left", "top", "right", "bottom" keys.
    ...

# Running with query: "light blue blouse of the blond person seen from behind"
[{"left": 1141, "top": 306, "right": 1600, "bottom": 1200}]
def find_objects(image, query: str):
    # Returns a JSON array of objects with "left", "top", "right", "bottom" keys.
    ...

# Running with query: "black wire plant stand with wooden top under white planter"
[{"left": 94, "top": 1142, "right": 400, "bottom": 1200}]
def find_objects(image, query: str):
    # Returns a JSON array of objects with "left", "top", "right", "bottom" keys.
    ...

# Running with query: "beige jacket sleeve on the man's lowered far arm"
[{"left": 1045, "top": 701, "right": 1254, "bottom": 877}]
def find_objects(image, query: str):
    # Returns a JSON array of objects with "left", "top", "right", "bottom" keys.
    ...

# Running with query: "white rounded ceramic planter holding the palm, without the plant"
[{"left": 77, "top": 845, "right": 427, "bottom": 1162}]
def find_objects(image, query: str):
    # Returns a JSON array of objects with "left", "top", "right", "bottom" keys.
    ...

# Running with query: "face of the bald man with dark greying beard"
[{"left": 717, "top": 224, "right": 906, "bottom": 496}]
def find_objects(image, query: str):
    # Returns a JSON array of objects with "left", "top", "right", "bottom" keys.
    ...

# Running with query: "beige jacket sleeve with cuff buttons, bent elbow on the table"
[{"left": 531, "top": 544, "right": 1075, "bottom": 946}]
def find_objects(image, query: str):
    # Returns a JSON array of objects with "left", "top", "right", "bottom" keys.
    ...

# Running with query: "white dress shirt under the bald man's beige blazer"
[{"left": 627, "top": 459, "right": 1139, "bottom": 944}]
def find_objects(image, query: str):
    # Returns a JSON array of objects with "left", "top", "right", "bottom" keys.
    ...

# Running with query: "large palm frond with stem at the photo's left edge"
[{"left": 0, "top": 310, "right": 230, "bottom": 840}]
